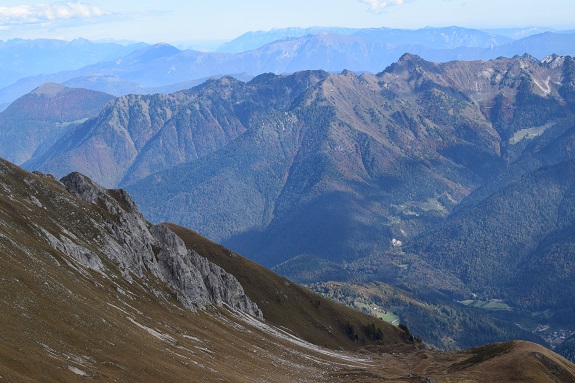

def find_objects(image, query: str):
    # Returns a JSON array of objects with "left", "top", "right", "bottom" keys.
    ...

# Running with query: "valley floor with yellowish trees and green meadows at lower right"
[{"left": 305, "top": 282, "right": 575, "bottom": 349}]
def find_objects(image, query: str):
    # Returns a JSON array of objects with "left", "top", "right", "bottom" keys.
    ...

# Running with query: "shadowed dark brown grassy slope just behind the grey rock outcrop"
[{"left": 165, "top": 223, "right": 404, "bottom": 348}]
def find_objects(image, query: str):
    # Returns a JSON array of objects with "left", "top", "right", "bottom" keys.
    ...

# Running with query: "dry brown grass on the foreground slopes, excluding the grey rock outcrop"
[{"left": 0, "top": 161, "right": 575, "bottom": 383}]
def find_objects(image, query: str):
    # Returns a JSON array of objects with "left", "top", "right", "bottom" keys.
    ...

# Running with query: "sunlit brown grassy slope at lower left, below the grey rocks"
[{"left": 0, "top": 161, "right": 399, "bottom": 382}]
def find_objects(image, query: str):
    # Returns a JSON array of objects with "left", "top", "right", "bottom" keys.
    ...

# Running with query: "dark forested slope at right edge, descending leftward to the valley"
[{"left": 407, "top": 143, "right": 575, "bottom": 311}]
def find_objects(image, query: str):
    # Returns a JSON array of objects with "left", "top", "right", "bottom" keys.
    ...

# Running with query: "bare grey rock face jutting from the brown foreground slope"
[{"left": 58, "top": 173, "right": 263, "bottom": 318}]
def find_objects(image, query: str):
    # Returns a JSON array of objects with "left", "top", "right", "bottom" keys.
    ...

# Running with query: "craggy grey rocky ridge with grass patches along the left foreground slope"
[{"left": 2, "top": 163, "right": 263, "bottom": 319}]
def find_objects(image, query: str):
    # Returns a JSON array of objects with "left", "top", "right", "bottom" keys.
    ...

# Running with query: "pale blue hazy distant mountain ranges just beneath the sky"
[{"left": 0, "top": 27, "right": 575, "bottom": 108}]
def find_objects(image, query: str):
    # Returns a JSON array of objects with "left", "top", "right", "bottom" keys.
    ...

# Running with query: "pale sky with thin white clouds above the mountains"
[{"left": 0, "top": 0, "right": 575, "bottom": 46}]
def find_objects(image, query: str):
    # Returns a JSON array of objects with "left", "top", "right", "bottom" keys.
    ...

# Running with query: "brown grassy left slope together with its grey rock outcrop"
[{"left": 0, "top": 161, "right": 403, "bottom": 381}]
